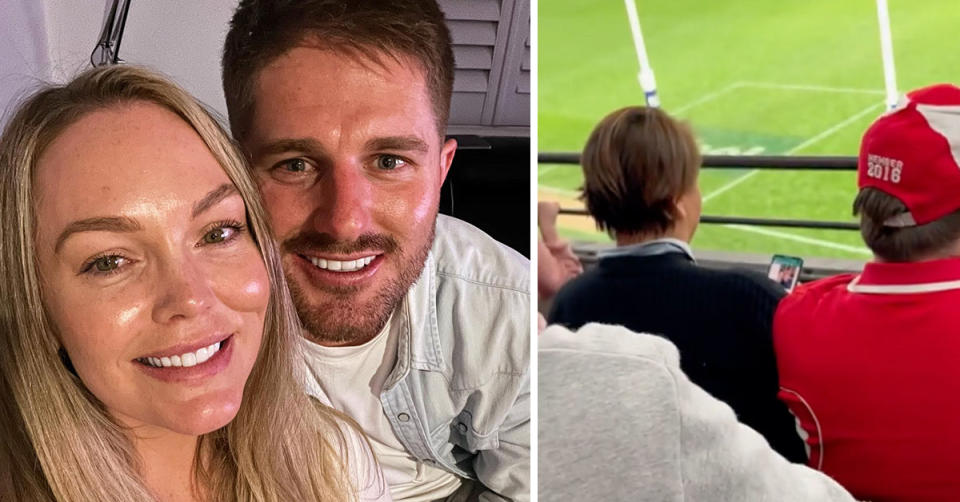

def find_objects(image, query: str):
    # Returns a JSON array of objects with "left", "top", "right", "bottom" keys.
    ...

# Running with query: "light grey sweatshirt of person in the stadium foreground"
[{"left": 538, "top": 324, "right": 854, "bottom": 502}]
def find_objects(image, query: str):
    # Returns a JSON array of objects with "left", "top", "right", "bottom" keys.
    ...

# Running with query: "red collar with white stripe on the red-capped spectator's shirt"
[{"left": 847, "top": 257, "right": 960, "bottom": 294}]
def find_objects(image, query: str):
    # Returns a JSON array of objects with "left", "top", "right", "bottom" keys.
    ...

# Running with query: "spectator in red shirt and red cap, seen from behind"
[{"left": 774, "top": 84, "right": 960, "bottom": 502}]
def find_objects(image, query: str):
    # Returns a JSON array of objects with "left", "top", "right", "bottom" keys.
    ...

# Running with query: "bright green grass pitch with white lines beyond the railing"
[{"left": 538, "top": 0, "right": 960, "bottom": 259}]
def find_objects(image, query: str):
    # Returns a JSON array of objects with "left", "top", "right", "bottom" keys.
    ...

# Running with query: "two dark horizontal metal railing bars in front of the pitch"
[{"left": 537, "top": 152, "right": 860, "bottom": 230}]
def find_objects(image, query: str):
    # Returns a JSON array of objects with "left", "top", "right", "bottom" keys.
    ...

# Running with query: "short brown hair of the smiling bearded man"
[{"left": 223, "top": 0, "right": 453, "bottom": 140}]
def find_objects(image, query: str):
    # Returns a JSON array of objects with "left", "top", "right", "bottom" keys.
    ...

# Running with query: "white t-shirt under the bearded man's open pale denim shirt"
[{"left": 304, "top": 321, "right": 461, "bottom": 502}]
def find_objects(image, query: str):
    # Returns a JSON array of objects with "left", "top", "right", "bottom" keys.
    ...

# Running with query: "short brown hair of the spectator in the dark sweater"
[{"left": 580, "top": 106, "right": 700, "bottom": 234}]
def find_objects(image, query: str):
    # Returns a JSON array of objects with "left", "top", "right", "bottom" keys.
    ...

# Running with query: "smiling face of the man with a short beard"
[{"left": 243, "top": 47, "right": 456, "bottom": 345}]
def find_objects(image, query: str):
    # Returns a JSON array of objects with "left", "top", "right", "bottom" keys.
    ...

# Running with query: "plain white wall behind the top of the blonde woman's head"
[{"left": 0, "top": 0, "right": 237, "bottom": 122}]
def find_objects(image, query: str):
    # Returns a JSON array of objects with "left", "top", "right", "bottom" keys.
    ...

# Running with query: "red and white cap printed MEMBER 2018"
[{"left": 857, "top": 84, "right": 960, "bottom": 227}]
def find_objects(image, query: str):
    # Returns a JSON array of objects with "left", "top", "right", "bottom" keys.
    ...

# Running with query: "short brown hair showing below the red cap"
[{"left": 853, "top": 187, "right": 960, "bottom": 262}]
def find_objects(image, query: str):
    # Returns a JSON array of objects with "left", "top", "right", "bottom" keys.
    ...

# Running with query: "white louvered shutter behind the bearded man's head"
[{"left": 440, "top": 0, "right": 530, "bottom": 133}]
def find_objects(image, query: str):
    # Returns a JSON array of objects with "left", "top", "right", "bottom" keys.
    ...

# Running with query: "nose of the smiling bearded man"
[{"left": 312, "top": 163, "right": 372, "bottom": 241}]
